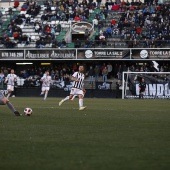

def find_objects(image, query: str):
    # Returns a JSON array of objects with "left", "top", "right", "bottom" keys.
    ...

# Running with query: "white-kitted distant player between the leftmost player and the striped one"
[{"left": 40, "top": 71, "right": 52, "bottom": 100}]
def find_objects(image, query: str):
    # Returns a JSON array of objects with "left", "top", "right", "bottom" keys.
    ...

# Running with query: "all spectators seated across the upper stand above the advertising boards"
[{"left": 0, "top": 0, "right": 170, "bottom": 48}]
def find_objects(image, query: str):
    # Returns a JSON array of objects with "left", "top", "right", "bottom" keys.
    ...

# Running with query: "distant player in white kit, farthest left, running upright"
[{"left": 5, "top": 69, "right": 17, "bottom": 98}]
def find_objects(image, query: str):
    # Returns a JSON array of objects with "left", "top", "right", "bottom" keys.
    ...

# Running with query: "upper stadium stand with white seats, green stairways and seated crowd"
[{"left": 0, "top": 0, "right": 170, "bottom": 48}]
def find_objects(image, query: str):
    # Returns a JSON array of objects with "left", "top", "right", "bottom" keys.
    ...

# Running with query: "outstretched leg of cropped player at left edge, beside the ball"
[{"left": 0, "top": 91, "right": 20, "bottom": 116}]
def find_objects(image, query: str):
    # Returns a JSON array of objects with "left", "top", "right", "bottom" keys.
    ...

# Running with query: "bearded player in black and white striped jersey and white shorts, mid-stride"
[{"left": 59, "top": 65, "right": 86, "bottom": 110}]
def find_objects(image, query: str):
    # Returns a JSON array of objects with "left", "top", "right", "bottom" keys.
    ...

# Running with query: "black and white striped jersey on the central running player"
[{"left": 72, "top": 72, "right": 85, "bottom": 89}]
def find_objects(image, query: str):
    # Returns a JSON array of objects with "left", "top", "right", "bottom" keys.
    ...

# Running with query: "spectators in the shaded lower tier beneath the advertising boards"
[{"left": 0, "top": 62, "right": 170, "bottom": 87}]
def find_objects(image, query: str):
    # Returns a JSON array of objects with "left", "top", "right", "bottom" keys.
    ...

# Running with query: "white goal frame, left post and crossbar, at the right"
[{"left": 122, "top": 71, "right": 170, "bottom": 99}]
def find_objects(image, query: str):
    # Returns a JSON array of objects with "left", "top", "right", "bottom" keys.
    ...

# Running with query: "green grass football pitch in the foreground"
[{"left": 0, "top": 98, "right": 170, "bottom": 170}]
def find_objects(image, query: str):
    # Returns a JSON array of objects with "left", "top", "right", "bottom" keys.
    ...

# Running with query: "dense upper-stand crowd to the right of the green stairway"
[{"left": 94, "top": 0, "right": 170, "bottom": 48}]
